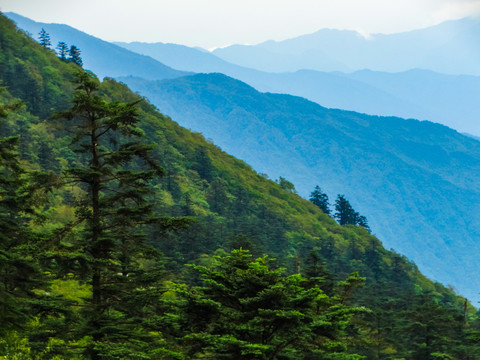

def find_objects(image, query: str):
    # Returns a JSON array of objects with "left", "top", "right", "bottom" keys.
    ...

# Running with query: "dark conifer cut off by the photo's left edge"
[{"left": 0, "top": 93, "right": 68, "bottom": 357}]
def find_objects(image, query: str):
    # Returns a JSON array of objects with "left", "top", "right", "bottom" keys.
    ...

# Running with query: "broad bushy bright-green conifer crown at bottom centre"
[{"left": 167, "top": 250, "right": 363, "bottom": 359}]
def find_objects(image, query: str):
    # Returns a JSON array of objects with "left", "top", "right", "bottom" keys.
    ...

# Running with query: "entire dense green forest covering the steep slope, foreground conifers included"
[{"left": 0, "top": 15, "right": 480, "bottom": 360}]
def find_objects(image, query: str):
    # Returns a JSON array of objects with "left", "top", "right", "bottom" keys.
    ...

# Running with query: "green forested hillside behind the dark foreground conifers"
[{"left": 0, "top": 10, "right": 479, "bottom": 360}]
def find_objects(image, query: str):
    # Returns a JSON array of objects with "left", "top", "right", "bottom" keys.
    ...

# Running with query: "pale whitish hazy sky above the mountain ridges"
[{"left": 0, "top": 0, "right": 480, "bottom": 49}]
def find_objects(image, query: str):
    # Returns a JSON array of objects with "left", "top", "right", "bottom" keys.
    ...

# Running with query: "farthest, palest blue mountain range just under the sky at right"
[{"left": 213, "top": 18, "right": 480, "bottom": 75}]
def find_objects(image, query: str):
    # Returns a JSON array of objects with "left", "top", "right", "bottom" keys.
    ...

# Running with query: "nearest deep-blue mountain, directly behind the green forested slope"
[{"left": 117, "top": 74, "right": 480, "bottom": 299}]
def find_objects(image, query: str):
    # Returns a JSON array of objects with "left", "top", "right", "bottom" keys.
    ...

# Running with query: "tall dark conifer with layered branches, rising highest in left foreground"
[{"left": 55, "top": 72, "right": 186, "bottom": 359}]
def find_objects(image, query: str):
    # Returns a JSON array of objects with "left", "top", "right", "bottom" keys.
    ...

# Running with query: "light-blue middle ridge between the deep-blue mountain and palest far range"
[{"left": 116, "top": 42, "right": 480, "bottom": 135}]
